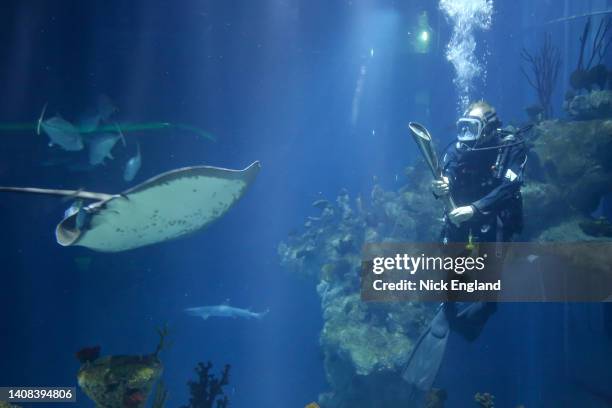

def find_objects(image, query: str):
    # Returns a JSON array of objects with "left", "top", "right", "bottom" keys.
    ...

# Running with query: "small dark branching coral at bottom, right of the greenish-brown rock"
[{"left": 181, "top": 362, "right": 230, "bottom": 408}]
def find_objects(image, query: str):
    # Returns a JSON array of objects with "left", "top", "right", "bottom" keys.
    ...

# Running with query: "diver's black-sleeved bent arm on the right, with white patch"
[{"left": 472, "top": 148, "right": 527, "bottom": 214}]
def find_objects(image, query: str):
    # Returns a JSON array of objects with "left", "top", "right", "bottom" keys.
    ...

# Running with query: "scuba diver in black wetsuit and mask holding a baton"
[{"left": 402, "top": 101, "right": 527, "bottom": 393}]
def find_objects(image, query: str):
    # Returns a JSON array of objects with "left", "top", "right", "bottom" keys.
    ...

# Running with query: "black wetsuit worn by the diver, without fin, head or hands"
[{"left": 442, "top": 134, "right": 527, "bottom": 340}]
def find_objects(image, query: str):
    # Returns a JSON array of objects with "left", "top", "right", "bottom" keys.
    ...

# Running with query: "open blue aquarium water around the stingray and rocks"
[{"left": 0, "top": 0, "right": 612, "bottom": 408}]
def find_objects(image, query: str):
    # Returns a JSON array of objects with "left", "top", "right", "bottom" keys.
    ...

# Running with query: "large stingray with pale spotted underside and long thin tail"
[{"left": 0, "top": 161, "right": 260, "bottom": 252}]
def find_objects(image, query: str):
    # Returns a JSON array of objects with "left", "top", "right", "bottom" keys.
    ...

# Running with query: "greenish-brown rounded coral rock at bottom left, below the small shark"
[{"left": 77, "top": 328, "right": 168, "bottom": 408}]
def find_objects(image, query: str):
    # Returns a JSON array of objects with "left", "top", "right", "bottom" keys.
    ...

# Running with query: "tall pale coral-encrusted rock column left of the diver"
[{"left": 279, "top": 164, "right": 441, "bottom": 408}]
